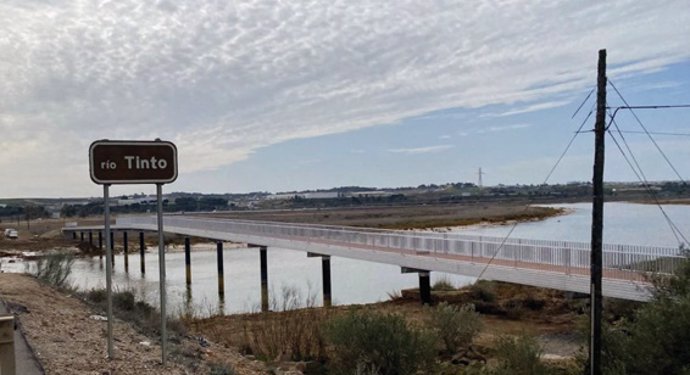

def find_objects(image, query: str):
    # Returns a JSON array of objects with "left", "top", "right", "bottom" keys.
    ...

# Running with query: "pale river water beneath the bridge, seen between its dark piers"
[{"left": 41, "top": 246, "right": 473, "bottom": 316}]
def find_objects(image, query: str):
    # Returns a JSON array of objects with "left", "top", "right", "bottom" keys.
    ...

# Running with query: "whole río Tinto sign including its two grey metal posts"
[{"left": 89, "top": 139, "right": 177, "bottom": 366}]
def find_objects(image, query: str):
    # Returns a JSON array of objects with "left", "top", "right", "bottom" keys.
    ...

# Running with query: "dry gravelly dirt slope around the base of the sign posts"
[{"left": 0, "top": 273, "right": 266, "bottom": 375}]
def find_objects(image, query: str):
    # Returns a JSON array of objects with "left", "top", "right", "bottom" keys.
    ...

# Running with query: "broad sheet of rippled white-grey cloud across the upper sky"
[{"left": 0, "top": 0, "right": 690, "bottom": 195}]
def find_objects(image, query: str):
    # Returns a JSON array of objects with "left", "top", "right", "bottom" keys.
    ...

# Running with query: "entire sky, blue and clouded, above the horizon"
[{"left": 0, "top": 0, "right": 690, "bottom": 198}]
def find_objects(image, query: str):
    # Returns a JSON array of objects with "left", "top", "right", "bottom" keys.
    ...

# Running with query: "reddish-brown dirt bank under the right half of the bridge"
[{"left": 187, "top": 283, "right": 583, "bottom": 370}]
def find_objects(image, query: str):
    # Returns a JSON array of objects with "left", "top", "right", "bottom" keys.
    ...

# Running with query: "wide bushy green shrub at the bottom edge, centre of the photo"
[{"left": 325, "top": 311, "right": 436, "bottom": 375}]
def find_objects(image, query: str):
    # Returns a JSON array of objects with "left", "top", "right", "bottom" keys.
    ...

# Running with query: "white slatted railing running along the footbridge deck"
[{"left": 118, "top": 216, "right": 684, "bottom": 280}]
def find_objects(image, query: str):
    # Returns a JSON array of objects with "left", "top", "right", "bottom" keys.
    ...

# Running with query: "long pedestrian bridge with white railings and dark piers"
[{"left": 63, "top": 215, "right": 684, "bottom": 303}]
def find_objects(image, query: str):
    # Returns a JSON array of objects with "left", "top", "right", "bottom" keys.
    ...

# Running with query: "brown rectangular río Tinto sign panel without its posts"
[{"left": 89, "top": 140, "right": 177, "bottom": 185}]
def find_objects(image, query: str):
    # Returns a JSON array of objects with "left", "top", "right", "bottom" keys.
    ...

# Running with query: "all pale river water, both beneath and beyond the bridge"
[{"left": 3, "top": 203, "right": 690, "bottom": 316}]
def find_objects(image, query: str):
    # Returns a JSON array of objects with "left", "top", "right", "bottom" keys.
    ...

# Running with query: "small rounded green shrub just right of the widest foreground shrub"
[{"left": 428, "top": 302, "right": 482, "bottom": 354}]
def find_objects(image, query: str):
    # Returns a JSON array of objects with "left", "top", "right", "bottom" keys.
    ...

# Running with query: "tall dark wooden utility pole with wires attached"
[{"left": 589, "top": 49, "right": 606, "bottom": 375}]
